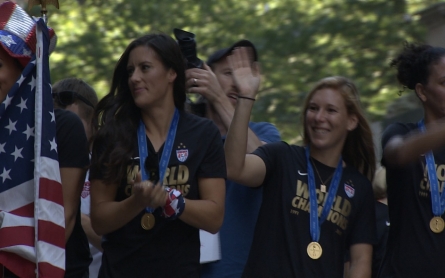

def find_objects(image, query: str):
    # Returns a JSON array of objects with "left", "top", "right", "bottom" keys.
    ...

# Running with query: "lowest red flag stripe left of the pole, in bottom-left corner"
[{"left": 0, "top": 251, "right": 36, "bottom": 278}]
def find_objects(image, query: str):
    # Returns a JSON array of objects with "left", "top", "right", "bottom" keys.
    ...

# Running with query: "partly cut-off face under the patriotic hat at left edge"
[{"left": 0, "top": 46, "right": 22, "bottom": 103}]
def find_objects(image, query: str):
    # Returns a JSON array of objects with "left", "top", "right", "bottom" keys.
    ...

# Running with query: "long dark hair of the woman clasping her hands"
[{"left": 91, "top": 33, "right": 186, "bottom": 184}]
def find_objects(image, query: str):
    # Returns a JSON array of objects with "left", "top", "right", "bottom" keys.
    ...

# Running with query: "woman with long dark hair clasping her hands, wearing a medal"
[{"left": 90, "top": 34, "right": 226, "bottom": 277}]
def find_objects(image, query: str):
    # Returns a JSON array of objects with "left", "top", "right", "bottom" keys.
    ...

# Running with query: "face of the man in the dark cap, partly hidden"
[{"left": 213, "top": 56, "right": 238, "bottom": 106}]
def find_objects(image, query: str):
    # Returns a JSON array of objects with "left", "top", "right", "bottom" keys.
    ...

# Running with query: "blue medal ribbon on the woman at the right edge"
[{"left": 418, "top": 119, "right": 445, "bottom": 217}]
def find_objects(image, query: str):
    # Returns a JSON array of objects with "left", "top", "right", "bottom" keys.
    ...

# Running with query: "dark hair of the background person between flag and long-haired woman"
[{"left": 52, "top": 77, "right": 99, "bottom": 120}]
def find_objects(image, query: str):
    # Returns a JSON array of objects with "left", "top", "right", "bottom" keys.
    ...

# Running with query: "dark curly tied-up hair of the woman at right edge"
[{"left": 390, "top": 42, "right": 445, "bottom": 90}]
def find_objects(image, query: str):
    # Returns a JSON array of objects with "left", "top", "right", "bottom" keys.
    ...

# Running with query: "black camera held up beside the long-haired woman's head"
[{"left": 173, "top": 28, "right": 202, "bottom": 69}]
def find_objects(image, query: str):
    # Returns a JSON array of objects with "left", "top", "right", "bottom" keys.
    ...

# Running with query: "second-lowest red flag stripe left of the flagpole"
[{"left": 0, "top": 226, "right": 34, "bottom": 248}]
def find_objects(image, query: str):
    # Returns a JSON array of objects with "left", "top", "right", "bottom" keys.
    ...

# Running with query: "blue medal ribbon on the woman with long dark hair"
[{"left": 138, "top": 108, "right": 179, "bottom": 213}]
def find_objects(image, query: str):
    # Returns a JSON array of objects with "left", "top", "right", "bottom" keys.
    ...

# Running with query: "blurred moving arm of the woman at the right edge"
[{"left": 383, "top": 121, "right": 445, "bottom": 166}]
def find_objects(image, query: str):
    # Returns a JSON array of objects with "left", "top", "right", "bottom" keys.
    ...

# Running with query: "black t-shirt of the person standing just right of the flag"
[{"left": 54, "top": 109, "right": 92, "bottom": 278}]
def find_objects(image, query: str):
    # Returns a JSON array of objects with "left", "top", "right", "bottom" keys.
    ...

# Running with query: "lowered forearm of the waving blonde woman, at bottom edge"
[{"left": 345, "top": 243, "right": 372, "bottom": 278}]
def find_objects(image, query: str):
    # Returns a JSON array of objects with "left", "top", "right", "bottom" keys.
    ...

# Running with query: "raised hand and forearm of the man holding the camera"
[{"left": 186, "top": 64, "right": 265, "bottom": 153}]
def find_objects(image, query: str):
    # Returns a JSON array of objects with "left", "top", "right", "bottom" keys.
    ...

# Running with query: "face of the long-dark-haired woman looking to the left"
[{"left": 127, "top": 46, "right": 176, "bottom": 108}]
